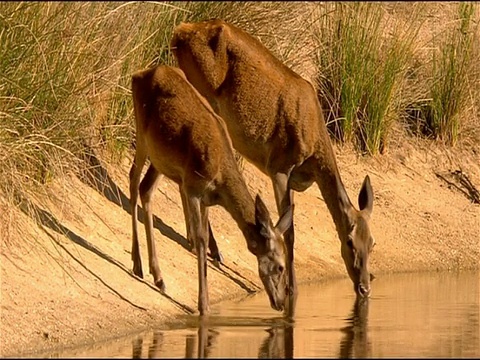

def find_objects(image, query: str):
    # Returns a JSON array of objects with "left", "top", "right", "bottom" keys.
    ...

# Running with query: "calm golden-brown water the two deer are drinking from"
[{"left": 33, "top": 272, "right": 480, "bottom": 358}]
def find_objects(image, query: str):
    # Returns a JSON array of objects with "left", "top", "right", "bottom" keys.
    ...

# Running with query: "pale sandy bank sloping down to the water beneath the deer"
[{"left": 0, "top": 134, "right": 480, "bottom": 357}]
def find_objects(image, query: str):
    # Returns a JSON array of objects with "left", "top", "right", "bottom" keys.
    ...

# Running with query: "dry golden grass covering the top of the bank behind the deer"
[{"left": 0, "top": 2, "right": 480, "bottom": 248}]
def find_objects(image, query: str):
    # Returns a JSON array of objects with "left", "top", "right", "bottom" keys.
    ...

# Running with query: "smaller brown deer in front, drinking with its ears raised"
[{"left": 130, "top": 66, "right": 293, "bottom": 315}]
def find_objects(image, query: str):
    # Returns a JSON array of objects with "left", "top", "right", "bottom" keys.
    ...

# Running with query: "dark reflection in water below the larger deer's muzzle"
[{"left": 339, "top": 296, "right": 371, "bottom": 359}]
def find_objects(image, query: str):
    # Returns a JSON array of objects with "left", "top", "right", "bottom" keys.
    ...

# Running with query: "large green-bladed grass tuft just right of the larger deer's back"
[{"left": 314, "top": 2, "right": 418, "bottom": 154}]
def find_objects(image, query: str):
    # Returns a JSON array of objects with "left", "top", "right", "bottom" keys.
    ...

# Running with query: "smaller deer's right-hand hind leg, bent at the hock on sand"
[{"left": 140, "top": 165, "right": 165, "bottom": 292}]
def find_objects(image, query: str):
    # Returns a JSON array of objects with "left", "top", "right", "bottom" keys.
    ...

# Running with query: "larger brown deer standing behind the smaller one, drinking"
[{"left": 171, "top": 19, "right": 374, "bottom": 301}]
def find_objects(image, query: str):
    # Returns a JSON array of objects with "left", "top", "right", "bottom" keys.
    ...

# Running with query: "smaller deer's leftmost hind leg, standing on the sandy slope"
[{"left": 130, "top": 148, "right": 147, "bottom": 278}]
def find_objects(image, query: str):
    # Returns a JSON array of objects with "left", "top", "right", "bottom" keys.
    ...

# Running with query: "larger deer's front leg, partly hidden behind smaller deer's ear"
[{"left": 272, "top": 173, "right": 298, "bottom": 312}]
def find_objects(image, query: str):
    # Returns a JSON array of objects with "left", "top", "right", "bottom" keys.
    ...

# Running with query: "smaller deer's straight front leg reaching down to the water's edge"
[{"left": 186, "top": 192, "right": 210, "bottom": 316}]
